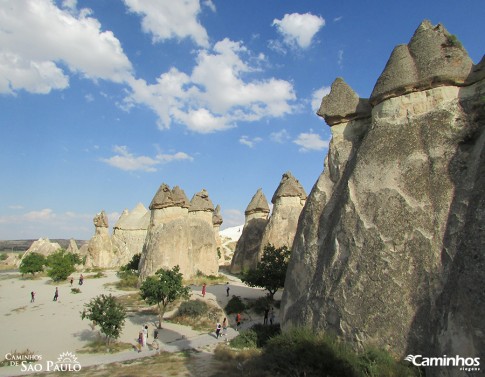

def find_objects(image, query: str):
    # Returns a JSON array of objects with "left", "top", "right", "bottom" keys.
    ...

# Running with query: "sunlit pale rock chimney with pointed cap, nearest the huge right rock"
[{"left": 258, "top": 172, "right": 307, "bottom": 254}]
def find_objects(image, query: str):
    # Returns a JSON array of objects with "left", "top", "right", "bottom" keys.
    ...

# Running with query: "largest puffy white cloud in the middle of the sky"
[{"left": 124, "top": 39, "right": 296, "bottom": 133}]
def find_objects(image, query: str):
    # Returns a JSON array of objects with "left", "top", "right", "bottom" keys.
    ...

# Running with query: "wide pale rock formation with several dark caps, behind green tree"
[{"left": 139, "top": 184, "right": 219, "bottom": 280}]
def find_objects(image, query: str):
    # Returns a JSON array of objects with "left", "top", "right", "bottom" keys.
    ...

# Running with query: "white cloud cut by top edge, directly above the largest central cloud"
[{"left": 124, "top": 0, "right": 208, "bottom": 47}]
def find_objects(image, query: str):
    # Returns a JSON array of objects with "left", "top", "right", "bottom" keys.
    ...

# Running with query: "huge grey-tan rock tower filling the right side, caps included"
[{"left": 281, "top": 21, "right": 485, "bottom": 376}]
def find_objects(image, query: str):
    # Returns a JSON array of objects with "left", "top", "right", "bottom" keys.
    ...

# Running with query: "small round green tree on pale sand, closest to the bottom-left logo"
[{"left": 81, "top": 294, "right": 126, "bottom": 344}]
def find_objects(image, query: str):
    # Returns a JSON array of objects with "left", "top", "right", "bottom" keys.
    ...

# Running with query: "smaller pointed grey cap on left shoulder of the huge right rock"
[{"left": 317, "top": 77, "right": 372, "bottom": 126}]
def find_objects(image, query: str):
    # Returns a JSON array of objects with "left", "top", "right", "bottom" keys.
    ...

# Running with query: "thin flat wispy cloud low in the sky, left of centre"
[{"left": 101, "top": 145, "right": 193, "bottom": 172}]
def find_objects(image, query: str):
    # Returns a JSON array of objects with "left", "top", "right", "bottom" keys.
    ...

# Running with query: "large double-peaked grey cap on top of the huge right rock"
[{"left": 370, "top": 20, "right": 473, "bottom": 105}]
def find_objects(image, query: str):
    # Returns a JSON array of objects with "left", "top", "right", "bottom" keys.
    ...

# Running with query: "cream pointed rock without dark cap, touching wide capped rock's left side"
[{"left": 112, "top": 203, "right": 150, "bottom": 266}]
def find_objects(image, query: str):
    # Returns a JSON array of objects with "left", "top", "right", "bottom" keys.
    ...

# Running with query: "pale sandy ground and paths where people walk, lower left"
[{"left": 0, "top": 271, "right": 277, "bottom": 376}]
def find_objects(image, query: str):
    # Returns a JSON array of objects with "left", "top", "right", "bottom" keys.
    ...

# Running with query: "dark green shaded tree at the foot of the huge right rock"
[{"left": 241, "top": 244, "right": 291, "bottom": 299}]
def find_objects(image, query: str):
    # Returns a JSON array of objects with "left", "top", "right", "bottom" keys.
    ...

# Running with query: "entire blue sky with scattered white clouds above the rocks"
[{"left": 0, "top": 0, "right": 485, "bottom": 239}]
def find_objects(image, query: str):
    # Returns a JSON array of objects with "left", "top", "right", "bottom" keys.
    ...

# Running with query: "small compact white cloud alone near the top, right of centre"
[{"left": 273, "top": 13, "right": 325, "bottom": 49}]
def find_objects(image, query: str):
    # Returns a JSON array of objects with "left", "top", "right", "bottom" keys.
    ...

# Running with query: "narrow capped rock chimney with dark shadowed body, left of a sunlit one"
[{"left": 230, "top": 189, "right": 269, "bottom": 273}]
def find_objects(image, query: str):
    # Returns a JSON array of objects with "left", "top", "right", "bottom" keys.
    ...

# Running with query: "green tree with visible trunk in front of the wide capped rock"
[{"left": 140, "top": 266, "right": 190, "bottom": 328}]
